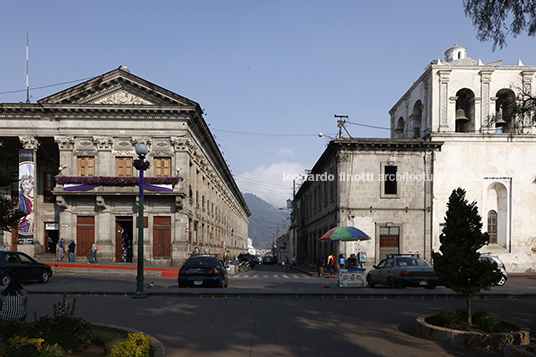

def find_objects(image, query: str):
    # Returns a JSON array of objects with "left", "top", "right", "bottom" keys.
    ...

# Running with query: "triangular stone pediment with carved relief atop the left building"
[{"left": 38, "top": 67, "right": 198, "bottom": 106}]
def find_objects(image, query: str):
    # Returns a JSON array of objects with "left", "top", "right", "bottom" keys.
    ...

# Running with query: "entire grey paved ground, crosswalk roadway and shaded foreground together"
[{"left": 15, "top": 266, "right": 536, "bottom": 357}]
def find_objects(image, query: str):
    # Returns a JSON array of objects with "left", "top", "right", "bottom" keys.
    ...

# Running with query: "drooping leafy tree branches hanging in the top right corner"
[{"left": 463, "top": 0, "right": 536, "bottom": 51}]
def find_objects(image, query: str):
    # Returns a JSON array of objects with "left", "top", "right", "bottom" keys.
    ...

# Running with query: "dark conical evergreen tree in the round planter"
[{"left": 432, "top": 188, "right": 501, "bottom": 325}]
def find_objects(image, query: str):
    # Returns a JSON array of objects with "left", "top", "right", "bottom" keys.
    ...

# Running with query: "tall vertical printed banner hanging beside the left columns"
[{"left": 19, "top": 149, "right": 35, "bottom": 244}]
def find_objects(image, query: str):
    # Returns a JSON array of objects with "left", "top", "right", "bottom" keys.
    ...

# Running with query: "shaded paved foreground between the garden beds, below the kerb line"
[{"left": 29, "top": 295, "right": 536, "bottom": 357}]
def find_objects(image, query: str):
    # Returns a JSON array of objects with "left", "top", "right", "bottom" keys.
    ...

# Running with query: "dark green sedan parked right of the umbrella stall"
[{"left": 367, "top": 254, "right": 439, "bottom": 289}]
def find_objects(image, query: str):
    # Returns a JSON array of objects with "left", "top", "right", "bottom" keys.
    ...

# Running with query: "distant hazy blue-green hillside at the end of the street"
[{"left": 242, "top": 193, "right": 289, "bottom": 249}]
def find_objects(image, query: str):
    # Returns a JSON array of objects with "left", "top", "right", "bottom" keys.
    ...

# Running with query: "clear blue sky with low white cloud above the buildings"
[{"left": 0, "top": 0, "right": 536, "bottom": 207}]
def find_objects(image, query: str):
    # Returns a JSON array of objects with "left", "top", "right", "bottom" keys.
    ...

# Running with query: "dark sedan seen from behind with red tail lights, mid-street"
[{"left": 178, "top": 255, "right": 229, "bottom": 288}]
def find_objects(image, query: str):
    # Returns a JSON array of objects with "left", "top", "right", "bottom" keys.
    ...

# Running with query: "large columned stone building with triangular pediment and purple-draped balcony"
[{"left": 0, "top": 67, "right": 250, "bottom": 265}]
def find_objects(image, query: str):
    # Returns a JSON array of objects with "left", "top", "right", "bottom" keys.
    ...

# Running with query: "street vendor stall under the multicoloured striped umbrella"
[{"left": 320, "top": 226, "right": 370, "bottom": 288}]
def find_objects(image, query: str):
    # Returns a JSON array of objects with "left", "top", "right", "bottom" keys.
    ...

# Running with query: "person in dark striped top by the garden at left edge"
[{"left": 0, "top": 279, "right": 28, "bottom": 322}]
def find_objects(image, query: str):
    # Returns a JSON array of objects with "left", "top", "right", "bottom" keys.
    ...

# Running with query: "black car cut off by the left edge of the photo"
[{"left": 0, "top": 250, "right": 52, "bottom": 285}]
